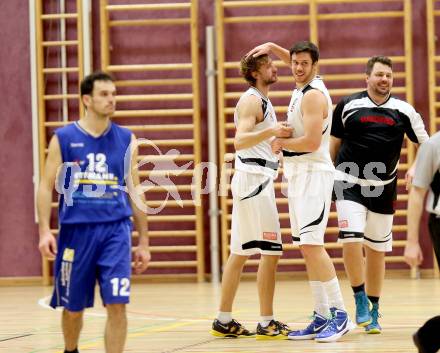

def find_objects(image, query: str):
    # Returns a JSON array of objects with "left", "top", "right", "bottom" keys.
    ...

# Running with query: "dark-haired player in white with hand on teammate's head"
[{"left": 248, "top": 41, "right": 354, "bottom": 342}]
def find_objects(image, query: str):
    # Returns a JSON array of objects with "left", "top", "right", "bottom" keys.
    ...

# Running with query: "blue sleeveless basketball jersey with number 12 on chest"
[{"left": 55, "top": 122, "right": 132, "bottom": 224}]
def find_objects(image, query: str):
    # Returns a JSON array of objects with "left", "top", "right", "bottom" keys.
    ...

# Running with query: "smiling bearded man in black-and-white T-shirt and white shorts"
[{"left": 330, "top": 56, "right": 428, "bottom": 334}]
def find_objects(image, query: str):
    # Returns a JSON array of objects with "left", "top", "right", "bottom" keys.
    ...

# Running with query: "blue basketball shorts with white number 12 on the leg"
[{"left": 50, "top": 219, "right": 132, "bottom": 311}]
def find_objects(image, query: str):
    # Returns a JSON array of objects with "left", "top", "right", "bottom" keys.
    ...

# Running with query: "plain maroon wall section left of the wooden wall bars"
[{"left": 0, "top": 0, "right": 41, "bottom": 277}]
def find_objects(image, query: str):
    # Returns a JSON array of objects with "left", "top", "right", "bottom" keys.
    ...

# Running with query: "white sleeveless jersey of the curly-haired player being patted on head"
[{"left": 234, "top": 87, "right": 279, "bottom": 179}]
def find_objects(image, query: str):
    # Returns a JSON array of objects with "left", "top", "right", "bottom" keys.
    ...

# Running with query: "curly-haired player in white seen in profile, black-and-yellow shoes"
[{"left": 211, "top": 55, "right": 292, "bottom": 339}]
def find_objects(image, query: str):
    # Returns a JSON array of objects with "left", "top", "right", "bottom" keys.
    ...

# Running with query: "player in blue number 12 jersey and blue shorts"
[{"left": 37, "top": 73, "right": 150, "bottom": 353}]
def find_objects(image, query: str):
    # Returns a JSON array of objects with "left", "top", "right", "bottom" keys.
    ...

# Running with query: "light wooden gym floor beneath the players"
[{"left": 0, "top": 278, "right": 440, "bottom": 353}]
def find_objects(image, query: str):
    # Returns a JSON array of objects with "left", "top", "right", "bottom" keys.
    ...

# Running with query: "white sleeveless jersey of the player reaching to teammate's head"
[{"left": 283, "top": 76, "right": 335, "bottom": 177}]
